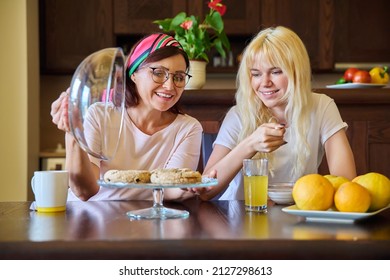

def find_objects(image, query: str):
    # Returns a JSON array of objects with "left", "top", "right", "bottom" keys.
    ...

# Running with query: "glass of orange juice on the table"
[{"left": 244, "top": 176, "right": 268, "bottom": 211}]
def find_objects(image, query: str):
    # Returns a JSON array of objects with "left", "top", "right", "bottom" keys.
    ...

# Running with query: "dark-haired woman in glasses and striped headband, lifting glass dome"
[{"left": 51, "top": 33, "right": 202, "bottom": 200}]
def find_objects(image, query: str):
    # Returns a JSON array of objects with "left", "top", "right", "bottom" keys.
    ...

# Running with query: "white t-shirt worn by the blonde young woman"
[{"left": 213, "top": 93, "right": 348, "bottom": 200}]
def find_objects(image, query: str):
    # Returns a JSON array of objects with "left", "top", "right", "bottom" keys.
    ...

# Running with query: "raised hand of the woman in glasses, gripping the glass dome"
[{"left": 50, "top": 88, "right": 70, "bottom": 132}]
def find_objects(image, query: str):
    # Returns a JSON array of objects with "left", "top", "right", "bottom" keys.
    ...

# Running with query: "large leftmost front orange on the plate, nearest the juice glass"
[{"left": 292, "top": 174, "right": 335, "bottom": 210}]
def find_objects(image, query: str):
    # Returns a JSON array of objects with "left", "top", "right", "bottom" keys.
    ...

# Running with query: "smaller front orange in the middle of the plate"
[{"left": 334, "top": 182, "right": 371, "bottom": 213}]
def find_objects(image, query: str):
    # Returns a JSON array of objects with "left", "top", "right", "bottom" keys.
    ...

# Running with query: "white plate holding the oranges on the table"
[{"left": 282, "top": 205, "right": 390, "bottom": 223}]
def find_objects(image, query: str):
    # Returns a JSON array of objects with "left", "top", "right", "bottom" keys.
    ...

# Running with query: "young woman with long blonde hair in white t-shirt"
[{"left": 200, "top": 26, "right": 356, "bottom": 200}]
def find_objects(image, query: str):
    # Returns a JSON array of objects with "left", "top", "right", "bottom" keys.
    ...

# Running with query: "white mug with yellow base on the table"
[{"left": 31, "top": 170, "right": 69, "bottom": 212}]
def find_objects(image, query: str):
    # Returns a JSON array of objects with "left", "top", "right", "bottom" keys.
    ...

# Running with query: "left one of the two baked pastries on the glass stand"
[{"left": 103, "top": 170, "right": 150, "bottom": 183}]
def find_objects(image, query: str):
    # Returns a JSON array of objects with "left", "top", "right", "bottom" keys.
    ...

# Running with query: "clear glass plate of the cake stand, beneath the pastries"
[{"left": 97, "top": 177, "right": 218, "bottom": 189}]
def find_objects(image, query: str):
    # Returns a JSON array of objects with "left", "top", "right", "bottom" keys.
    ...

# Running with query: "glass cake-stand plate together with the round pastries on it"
[{"left": 98, "top": 168, "right": 218, "bottom": 189}]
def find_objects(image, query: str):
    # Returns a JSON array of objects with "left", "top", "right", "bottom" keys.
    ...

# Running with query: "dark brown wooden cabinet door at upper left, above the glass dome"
[{"left": 39, "top": 0, "right": 115, "bottom": 74}]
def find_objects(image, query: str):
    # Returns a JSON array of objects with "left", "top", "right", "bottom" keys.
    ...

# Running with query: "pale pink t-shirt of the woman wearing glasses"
[{"left": 68, "top": 103, "right": 203, "bottom": 200}]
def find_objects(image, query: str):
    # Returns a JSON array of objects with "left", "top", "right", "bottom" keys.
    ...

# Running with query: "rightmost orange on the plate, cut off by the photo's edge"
[{"left": 352, "top": 172, "right": 390, "bottom": 211}]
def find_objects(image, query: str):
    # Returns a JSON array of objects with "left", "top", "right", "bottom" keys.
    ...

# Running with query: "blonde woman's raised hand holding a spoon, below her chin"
[{"left": 249, "top": 123, "right": 287, "bottom": 153}]
